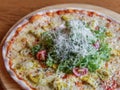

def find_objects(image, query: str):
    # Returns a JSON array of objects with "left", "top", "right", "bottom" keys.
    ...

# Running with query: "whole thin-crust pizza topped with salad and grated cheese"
[{"left": 3, "top": 8, "right": 120, "bottom": 90}]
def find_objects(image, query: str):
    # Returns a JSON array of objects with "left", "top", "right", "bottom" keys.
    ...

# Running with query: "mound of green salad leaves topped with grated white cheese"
[{"left": 32, "top": 20, "right": 110, "bottom": 73}]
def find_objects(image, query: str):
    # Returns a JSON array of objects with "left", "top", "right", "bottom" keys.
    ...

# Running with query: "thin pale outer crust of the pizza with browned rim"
[{"left": 3, "top": 5, "right": 120, "bottom": 90}]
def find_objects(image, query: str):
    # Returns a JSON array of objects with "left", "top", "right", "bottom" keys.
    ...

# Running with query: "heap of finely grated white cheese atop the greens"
[{"left": 54, "top": 20, "right": 96, "bottom": 60}]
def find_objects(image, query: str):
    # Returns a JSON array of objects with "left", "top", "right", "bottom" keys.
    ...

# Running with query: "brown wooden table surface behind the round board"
[{"left": 0, "top": 0, "right": 120, "bottom": 90}]
